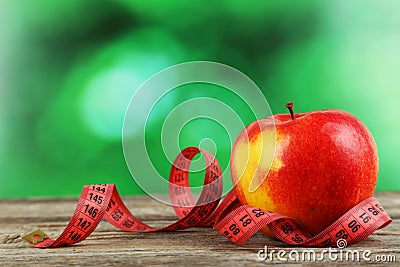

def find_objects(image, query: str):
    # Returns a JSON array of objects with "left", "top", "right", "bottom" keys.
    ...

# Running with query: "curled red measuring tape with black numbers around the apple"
[{"left": 24, "top": 147, "right": 392, "bottom": 248}]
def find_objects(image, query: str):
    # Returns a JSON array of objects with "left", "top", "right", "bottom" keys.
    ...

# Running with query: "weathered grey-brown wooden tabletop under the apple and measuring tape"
[{"left": 0, "top": 192, "right": 400, "bottom": 266}]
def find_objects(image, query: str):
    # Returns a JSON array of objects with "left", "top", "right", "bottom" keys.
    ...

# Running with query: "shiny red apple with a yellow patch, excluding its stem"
[{"left": 230, "top": 109, "right": 379, "bottom": 235}]
